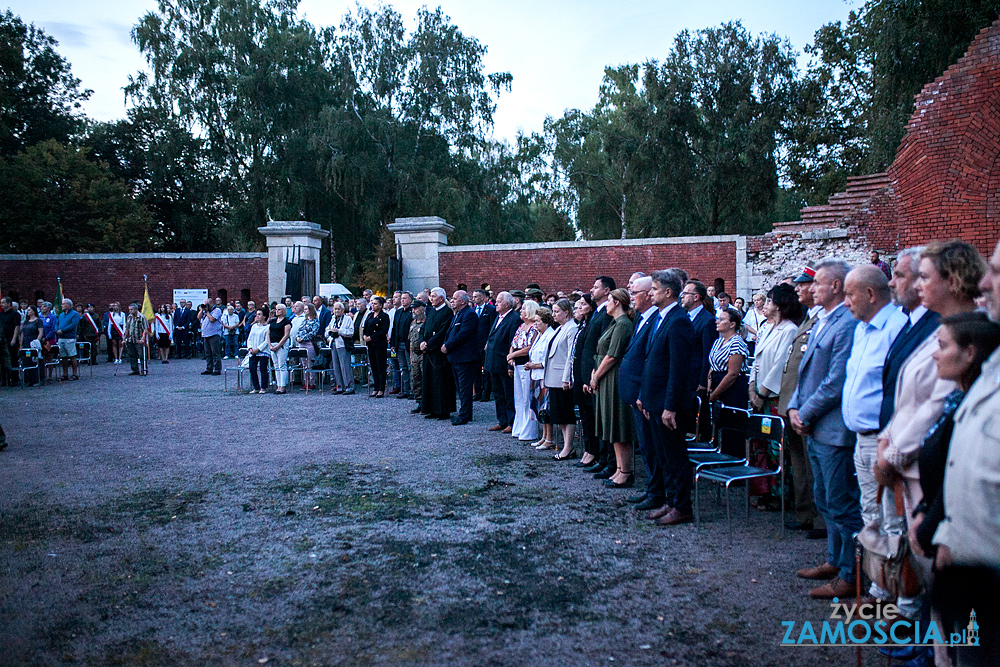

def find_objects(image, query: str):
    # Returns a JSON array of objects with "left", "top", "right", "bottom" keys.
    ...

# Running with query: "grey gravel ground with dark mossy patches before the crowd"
[{"left": 0, "top": 361, "right": 883, "bottom": 667}]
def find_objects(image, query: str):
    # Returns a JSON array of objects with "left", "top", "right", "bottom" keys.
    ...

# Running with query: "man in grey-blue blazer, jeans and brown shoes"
[{"left": 788, "top": 258, "right": 863, "bottom": 600}]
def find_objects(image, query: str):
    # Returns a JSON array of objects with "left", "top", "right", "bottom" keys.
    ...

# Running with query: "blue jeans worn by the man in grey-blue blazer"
[{"left": 806, "top": 436, "right": 864, "bottom": 584}]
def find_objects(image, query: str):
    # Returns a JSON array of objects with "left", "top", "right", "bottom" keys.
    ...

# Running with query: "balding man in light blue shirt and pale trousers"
[{"left": 841, "top": 264, "right": 907, "bottom": 604}]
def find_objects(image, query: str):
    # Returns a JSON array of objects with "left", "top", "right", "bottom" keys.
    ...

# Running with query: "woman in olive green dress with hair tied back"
[{"left": 588, "top": 288, "right": 635, "bottom": 489}]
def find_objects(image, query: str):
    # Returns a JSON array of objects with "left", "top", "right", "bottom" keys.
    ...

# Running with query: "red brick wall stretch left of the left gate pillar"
[{"left": 0, "top": 255, "right": 267, "bottom": 311}]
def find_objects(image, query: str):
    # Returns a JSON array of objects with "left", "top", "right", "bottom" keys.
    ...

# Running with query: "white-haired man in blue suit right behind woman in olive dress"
[{"left": 618, "top": 276, "right": 666, "bottom": 510}]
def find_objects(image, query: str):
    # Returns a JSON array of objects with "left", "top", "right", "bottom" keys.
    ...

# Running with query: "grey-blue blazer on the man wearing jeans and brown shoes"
[{"left": 788, "top": 305, "right": 858, "bottom": 447}]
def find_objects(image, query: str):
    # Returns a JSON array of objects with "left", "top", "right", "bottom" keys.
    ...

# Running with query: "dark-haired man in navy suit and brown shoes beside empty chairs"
[{"left": 636, "top": 270, "right": 696, "bottom": 526}]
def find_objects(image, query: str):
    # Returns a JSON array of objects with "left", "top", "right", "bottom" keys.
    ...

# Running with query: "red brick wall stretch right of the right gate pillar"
[{"left": 438, "top": 240, "right": 736, "bottom": 294}]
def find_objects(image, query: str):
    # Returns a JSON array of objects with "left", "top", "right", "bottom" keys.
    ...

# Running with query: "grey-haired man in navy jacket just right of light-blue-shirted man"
[{"left": 879, "top": 248, "right": 939, "bottom": 429}]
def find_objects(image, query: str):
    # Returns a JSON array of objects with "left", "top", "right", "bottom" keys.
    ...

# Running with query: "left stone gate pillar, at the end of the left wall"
[{"left": 257, "top": 220, "right": 330, "bottom": 303}]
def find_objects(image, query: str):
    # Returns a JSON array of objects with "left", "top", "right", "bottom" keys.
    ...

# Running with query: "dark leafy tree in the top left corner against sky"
[{"left": 0, "top": 9, "right": 91, "bottom": 156}]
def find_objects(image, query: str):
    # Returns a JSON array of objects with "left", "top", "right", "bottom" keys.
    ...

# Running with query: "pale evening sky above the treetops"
[{"left": 0, "top": 0, "right": 863, "bottom": 144}]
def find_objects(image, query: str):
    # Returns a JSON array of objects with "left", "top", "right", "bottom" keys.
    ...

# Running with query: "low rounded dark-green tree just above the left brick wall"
[{"left": 0, "top": 139, "right": 153, "bottom": 253}]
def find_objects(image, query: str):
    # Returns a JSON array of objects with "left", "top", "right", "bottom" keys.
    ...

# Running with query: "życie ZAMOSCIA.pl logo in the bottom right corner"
[{"left": 781, "top": 598, "right": 979, "bottom": 647}]
